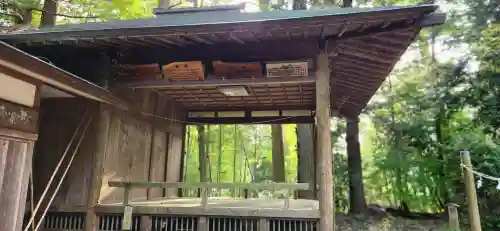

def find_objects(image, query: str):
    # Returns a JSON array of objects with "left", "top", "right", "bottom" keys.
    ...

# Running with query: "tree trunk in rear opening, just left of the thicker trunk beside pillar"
[{"left": 271, "top": 124, "right": 285, "bottom": 182}]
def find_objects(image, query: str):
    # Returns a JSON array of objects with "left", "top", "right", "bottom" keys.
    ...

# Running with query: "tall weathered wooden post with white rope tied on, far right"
[{"left": 460, "top": 151, "right": 481, "bottom": 231}]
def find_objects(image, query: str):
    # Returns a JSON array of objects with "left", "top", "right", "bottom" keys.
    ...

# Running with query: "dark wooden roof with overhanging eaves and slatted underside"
[{"left": 0, "top": 5, "right": 444, "bottom": 115}]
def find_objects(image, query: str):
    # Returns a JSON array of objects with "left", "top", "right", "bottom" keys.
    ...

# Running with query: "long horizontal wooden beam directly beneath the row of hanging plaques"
[{"left": 122, "top": 76, "right": 316, "bottom": 89}]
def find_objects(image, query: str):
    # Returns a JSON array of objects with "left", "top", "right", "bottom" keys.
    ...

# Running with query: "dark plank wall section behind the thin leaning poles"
[{"left": 33, "top": 98, "right": 98, "bottom": 209}]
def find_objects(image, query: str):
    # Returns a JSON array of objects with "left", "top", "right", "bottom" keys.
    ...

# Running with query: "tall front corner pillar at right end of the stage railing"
[{"left": 316, "top": 49, "right": 334, "bottom": 231}]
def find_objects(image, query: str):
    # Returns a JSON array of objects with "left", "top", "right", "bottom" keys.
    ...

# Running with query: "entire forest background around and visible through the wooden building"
[{"left": 0, "top": 0, "right": 500, "bottom": 230}]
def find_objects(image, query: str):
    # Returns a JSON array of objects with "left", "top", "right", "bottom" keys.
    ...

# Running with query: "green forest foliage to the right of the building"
[{"left": 363, "top": 1, "right": 500, "bottom": 227}]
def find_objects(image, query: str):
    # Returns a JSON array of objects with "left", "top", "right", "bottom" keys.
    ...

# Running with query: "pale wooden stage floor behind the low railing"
[{"left": 95, "top": 198, "right": 319, "bottom": 219}]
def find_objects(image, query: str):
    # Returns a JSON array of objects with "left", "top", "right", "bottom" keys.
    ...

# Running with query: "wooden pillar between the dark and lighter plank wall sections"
[{"left": 84, "top": 106, "right": 111, "bottom": 231}]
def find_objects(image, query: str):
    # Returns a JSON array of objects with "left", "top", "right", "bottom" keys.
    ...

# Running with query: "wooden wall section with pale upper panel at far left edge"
[{"left": 0, "top": 81, "right": 39, "bottom": 231}]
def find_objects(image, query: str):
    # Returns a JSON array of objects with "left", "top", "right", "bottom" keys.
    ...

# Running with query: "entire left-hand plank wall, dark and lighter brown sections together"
[{"left": 34, "top": 91, "right": 185, "bottom": 208}]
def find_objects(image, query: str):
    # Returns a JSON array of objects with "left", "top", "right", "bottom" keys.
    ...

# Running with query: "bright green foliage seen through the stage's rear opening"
[{"left": 184, "top": 125, "right": 297, "bottom": 188}]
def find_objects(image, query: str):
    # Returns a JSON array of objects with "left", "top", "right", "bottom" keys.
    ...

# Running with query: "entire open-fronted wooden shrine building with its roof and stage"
[{"left": 0, "top": 5, "right": 445, "bottom": 231}]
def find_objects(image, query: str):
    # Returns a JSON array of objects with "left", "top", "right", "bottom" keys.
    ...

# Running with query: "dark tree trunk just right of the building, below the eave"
[{"left": 346, "top": 118, "right": 366, "bottom": 214}]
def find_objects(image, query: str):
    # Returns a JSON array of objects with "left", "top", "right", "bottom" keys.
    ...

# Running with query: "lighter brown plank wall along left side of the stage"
[{"left": 99, "top": 90, "right": 185, "bottom": 203}]
